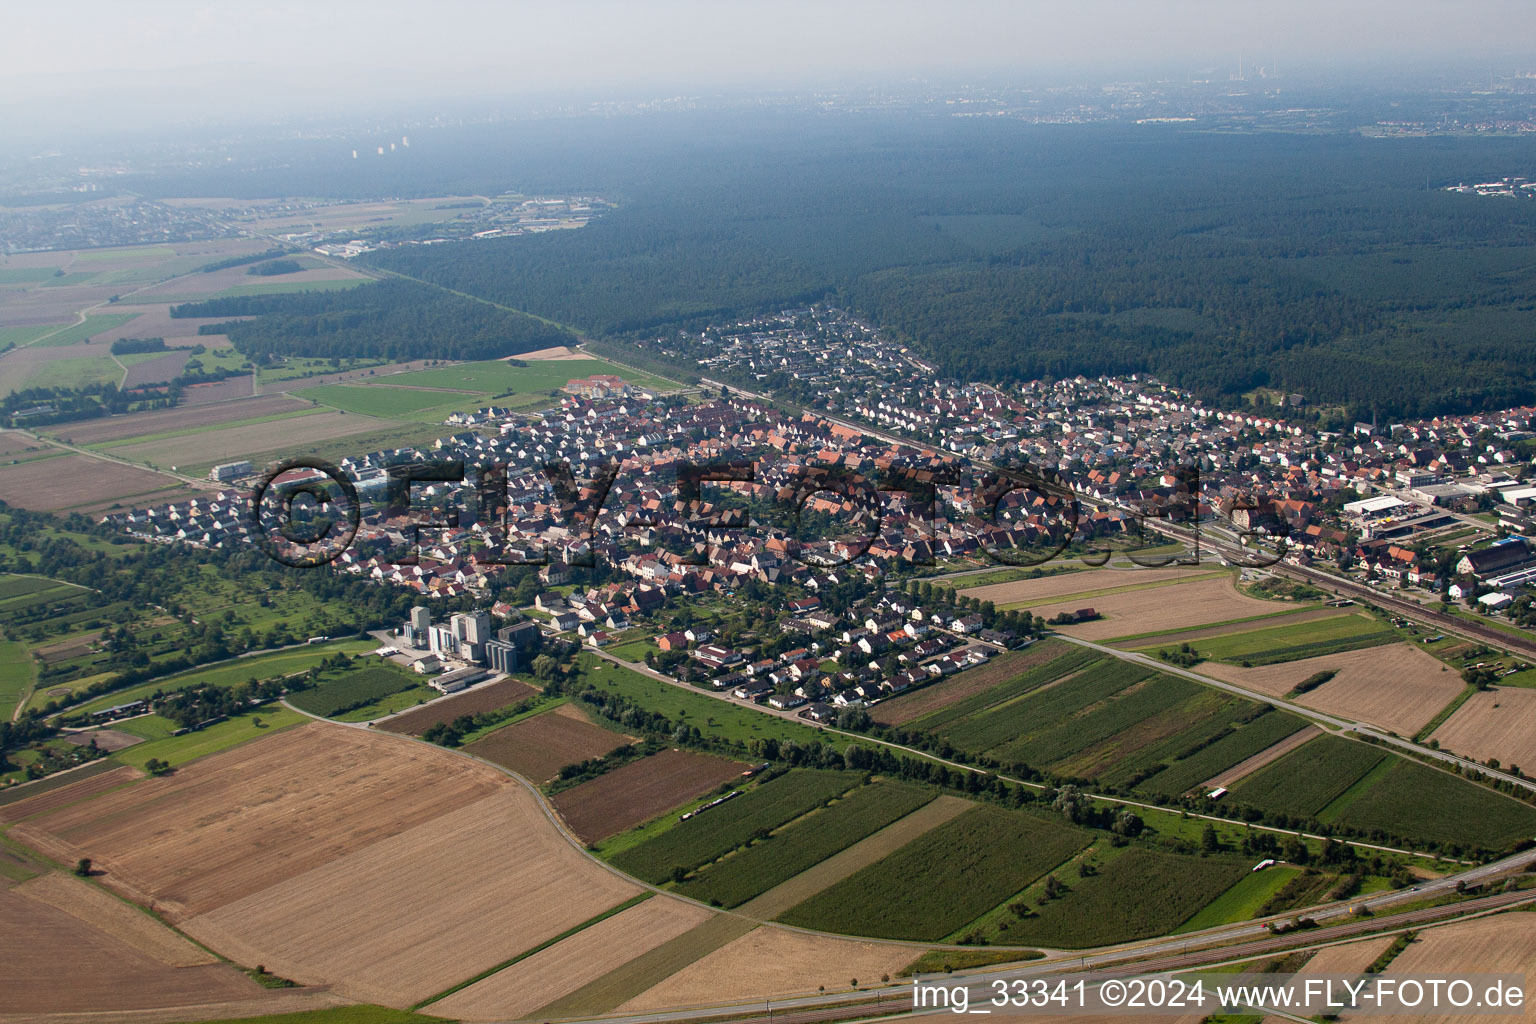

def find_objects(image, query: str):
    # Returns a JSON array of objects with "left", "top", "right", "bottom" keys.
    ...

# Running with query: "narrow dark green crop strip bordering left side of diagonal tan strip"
[{"left": 677, "top": 781, "right": 934, "bottom": 907}]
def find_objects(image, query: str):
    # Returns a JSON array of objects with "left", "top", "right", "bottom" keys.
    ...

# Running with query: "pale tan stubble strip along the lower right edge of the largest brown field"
[{"left": 425, "top": 897, "right": 711, "bottom": 1021}]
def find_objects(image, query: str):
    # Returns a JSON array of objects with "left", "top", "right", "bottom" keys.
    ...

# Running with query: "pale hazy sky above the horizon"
[{"left": 0, "top": 0, "right": 1536, "bottom": 138}]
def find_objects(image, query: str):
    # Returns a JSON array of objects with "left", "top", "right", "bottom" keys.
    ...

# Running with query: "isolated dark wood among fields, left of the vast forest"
[{"left": 170, "top": 279, "right": 576, "bottom": 365}]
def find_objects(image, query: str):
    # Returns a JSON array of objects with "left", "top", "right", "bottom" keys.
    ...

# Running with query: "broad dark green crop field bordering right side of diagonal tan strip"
[{"left": 779, "top": 806, "right": 1087, "bottom": 941}]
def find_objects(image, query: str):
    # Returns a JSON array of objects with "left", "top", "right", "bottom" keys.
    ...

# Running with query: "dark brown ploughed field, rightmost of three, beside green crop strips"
[{"left": 551, "top": 748, "right": 746, "bottom": 843}]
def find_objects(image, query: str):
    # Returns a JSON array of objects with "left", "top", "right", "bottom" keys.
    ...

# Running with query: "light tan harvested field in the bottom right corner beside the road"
[{"left": 1376, "top": 912, "right": 1536, "bottom": 1024}]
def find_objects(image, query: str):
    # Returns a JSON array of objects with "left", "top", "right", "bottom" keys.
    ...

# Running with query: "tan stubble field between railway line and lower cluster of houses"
[{"left": 1029, "top": 570, "right": 1284, "bottom": 640}]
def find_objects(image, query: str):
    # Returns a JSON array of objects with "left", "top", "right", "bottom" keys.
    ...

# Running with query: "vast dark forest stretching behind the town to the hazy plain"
[{"left": 330, "top": 123, "right": 1536, "bottom": 419}]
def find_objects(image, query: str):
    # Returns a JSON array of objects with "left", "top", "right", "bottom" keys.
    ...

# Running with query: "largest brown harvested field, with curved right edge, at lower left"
[{"left": 11, "top": 723, "right": 651, "bottom": 1007}]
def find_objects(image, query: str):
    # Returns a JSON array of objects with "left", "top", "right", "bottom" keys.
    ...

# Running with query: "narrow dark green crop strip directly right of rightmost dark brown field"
[{"left": 611, "top": 771, "right": 860, "bottom": 884}]
